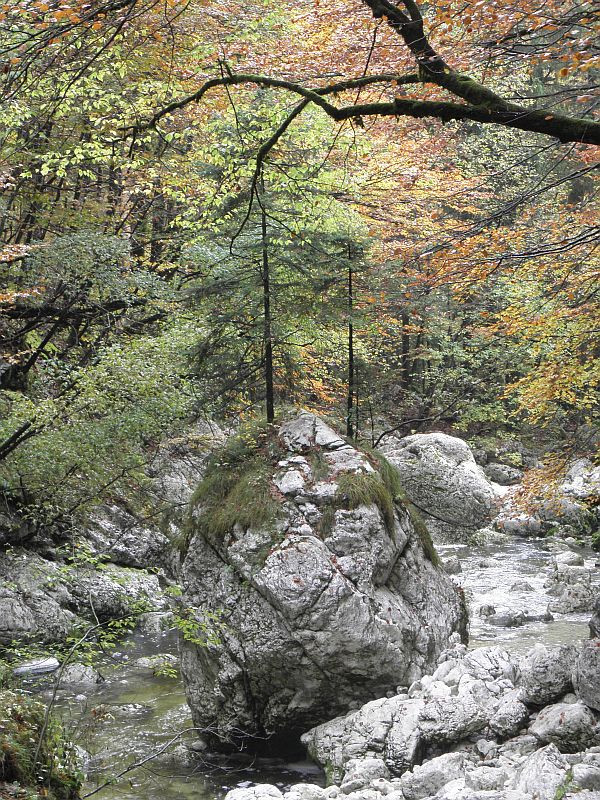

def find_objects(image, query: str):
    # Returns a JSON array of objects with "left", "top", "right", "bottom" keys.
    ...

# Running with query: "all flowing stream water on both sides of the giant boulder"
[{"left": 51, "top": 540, "right": 594, "bottom": 800}]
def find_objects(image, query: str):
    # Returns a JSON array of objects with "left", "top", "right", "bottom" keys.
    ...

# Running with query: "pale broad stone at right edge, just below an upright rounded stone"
[{"left": 529, "top": 703, "right": 598, "bottom": 753}]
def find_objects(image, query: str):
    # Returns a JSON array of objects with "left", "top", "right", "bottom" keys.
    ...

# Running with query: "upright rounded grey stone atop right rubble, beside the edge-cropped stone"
[{"left": 519, "top": 644, "right": 577, "bottom": 706}]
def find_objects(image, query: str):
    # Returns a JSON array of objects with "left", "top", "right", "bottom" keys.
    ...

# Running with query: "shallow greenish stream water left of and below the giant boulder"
[{"left": 47, "top": 634, "right": 324, "bottom": 800}]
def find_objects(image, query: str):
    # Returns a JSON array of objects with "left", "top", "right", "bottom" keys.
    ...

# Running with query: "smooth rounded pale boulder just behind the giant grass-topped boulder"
[{"left": 382, "top": 433, "right": 495, "bottom": 541}]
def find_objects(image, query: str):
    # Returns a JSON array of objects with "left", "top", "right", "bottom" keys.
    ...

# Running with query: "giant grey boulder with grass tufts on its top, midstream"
[{"left": 181, "top": 413, "right": 464, "bottom": 749}]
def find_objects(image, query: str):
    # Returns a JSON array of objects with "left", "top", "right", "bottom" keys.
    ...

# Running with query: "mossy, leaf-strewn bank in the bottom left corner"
[{"left": 0, "top": 690, "right": 83, "bottom": 800}]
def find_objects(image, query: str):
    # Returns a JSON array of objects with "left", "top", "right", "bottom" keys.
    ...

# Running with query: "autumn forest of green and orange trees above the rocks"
[{"left": 0, "top": 0, "right": 600, "bottom": 524}]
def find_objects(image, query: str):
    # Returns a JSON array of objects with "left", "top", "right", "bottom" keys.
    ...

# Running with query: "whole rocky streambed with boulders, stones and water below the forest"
[{"left": 0, "top": 414, "right": 600, "bottom": 800}]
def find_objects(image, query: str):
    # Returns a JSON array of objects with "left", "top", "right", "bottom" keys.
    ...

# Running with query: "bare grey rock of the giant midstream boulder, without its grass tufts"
[{"left": 181, "top": 414, "right": 463, "bottom": 748}]
